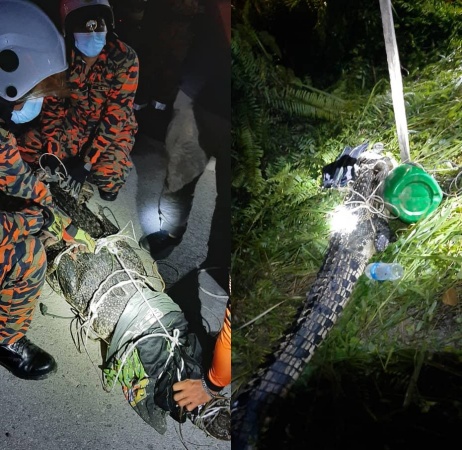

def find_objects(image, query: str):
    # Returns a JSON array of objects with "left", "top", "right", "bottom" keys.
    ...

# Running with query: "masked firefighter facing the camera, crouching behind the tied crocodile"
[{"left": 19, "top": 0, "right": 138, "bottom": 201}]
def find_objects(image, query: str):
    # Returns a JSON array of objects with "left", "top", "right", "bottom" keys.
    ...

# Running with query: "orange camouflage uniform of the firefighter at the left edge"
[{"left": 0, "top": 128, "right": 52, "bottom": 344}]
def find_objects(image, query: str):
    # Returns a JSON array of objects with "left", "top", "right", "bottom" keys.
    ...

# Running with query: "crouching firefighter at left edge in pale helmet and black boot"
[{"left": 0, "top": 0, "right": 94, "bottom": 380}]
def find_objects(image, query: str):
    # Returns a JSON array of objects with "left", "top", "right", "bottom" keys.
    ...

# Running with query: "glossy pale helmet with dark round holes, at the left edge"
[{"left": 0, "top": 0, "right": 67, "bottom": 101}]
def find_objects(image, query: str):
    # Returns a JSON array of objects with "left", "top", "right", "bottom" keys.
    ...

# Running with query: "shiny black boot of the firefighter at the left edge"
[{"left": 0, "top": 336, "right": 58, "bottom": 380}]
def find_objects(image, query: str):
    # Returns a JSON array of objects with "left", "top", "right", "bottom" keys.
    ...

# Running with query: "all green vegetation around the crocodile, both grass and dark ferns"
[{"left": 232, "top": 0, "right": 462, "bottom": 414}]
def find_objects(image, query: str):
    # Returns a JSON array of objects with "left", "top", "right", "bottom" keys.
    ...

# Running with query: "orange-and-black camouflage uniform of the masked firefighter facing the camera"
[{"left": 18, "top": 39, "right": 139, "bottom": 192}]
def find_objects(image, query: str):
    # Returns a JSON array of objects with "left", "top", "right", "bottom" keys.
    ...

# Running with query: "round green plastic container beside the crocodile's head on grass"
[{"left": 383, "top": 164, "right": 443, "bottom": 223}]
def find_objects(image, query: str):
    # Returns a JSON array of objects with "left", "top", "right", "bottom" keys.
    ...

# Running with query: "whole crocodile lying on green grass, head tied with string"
[{"left": 232, "top": 152, "right": 396, "bottom": 450}]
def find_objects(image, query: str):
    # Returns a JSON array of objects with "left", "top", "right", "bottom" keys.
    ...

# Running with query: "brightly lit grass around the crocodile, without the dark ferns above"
[{"left": 233, "top": 38, "right": 462, "bottom": 402}]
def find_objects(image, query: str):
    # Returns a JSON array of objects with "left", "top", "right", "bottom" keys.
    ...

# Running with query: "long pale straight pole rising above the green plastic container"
[{"left": 380, "top": 0, "right": 410, "bottom": 163}]
